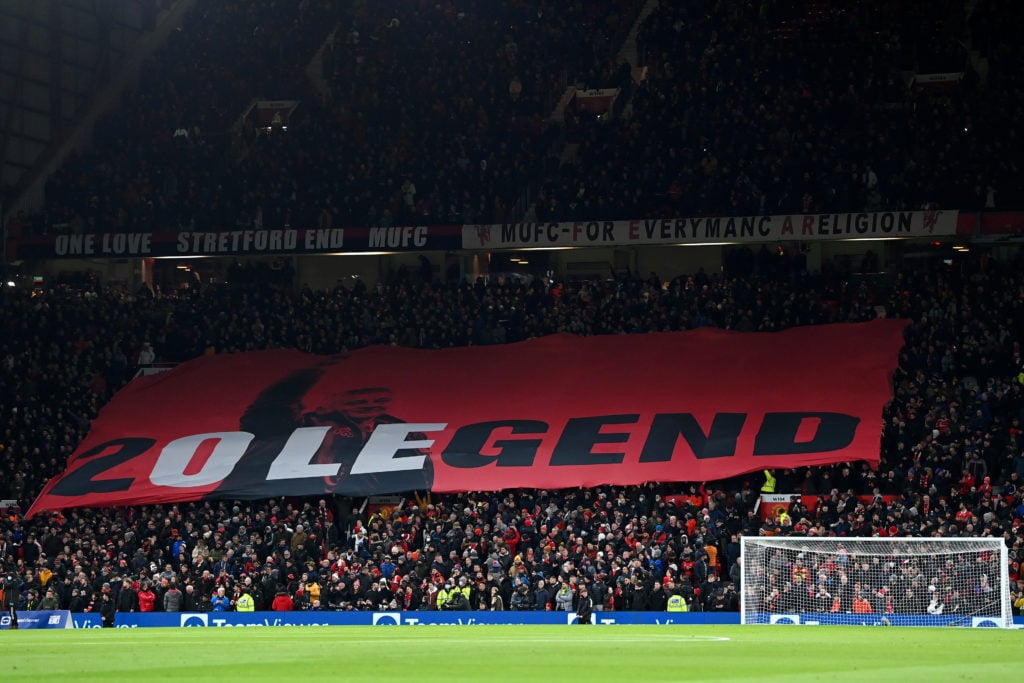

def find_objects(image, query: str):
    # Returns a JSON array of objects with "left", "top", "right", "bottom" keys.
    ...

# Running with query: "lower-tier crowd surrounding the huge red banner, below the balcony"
[{"left": 0, "top": 252, "right": 1024, "bottom": 610}]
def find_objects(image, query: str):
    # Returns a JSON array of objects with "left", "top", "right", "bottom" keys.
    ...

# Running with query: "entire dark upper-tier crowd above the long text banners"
[{"left": 9, "top": 0, "right": 1024, "bottom": 239}]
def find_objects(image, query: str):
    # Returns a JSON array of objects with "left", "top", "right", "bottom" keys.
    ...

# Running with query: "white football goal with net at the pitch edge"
[{"left": 740, "top": 537, "right": 1013, "bottom": 628}]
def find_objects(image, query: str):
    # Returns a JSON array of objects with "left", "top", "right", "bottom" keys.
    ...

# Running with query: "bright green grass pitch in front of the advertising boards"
[{"left": 0, "top": 626, "right": 1024, "bottom": 683}]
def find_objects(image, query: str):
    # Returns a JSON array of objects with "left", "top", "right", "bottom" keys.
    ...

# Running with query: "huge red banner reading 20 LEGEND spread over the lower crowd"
[{"left": 24, "top": 319, "right": 906, "bottom": 515}]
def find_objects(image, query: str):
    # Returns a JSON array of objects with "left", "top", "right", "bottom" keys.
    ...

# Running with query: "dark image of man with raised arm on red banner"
[{"left": 217, "top": 360, "right": 434, "bottom": 498}]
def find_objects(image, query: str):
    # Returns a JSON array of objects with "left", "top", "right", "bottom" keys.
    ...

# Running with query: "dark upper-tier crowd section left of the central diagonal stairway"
[{"left": 13, "top": 0, "right": 637, "bottom": 233}]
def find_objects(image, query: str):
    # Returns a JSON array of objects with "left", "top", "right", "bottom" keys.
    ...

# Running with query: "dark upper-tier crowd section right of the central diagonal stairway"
[{"left": 538, "top": 0, "right": 1024, "bottom": 220}]
